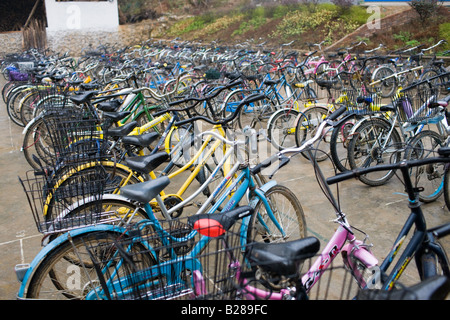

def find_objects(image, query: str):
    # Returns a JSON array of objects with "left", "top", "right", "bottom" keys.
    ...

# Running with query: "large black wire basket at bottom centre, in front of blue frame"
[{"left": 74, "top": 218, "right": 250, "bottom": 300}]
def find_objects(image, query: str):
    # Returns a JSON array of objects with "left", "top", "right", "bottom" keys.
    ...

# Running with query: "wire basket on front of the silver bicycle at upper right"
[{"left": 392, "top": 81, "right": 439, "bottom": 123}]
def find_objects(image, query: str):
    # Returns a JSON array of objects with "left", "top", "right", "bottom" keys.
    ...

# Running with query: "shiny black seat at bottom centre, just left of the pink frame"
[{"left": 247, "top": 237, "right": 320, "bottom": 276}]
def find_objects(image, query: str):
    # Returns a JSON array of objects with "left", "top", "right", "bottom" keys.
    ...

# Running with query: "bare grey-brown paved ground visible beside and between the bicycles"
[{"left": 0, "top": 80, "right": 450, "bottom": 300}]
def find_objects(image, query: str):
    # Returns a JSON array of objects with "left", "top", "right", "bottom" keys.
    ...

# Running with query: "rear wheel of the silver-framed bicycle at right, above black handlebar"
[{"left": 348, "top": 119, "right": 401, "bottom": 186}]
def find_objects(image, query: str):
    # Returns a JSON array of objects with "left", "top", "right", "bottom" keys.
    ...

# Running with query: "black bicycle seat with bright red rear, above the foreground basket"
[{"left": 188, "top": 206, "right": 253, "bottom": 237}]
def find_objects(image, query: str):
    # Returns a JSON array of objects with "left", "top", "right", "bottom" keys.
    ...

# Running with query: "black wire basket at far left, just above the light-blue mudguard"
[{"left": 19, "top": 166, "right": 123, "bottom": 234}]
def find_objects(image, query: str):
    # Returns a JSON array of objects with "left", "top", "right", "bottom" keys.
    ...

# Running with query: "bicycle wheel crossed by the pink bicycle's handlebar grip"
[{"left": 295, "top": 106, "right": 332, "bottom": 161}]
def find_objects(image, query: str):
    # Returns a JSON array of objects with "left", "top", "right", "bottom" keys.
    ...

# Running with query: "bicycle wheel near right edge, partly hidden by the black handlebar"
[{"left": 405, "top": 130, "right": 445, "bottom": 203}]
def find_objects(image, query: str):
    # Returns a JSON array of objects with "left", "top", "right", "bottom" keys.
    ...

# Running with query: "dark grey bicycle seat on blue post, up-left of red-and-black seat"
[{"left": 120, "top": 177, "right": 170, "bottom": 203}]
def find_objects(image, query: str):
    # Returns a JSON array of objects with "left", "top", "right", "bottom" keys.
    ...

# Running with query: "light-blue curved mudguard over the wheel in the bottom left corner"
[{"left": 16, "top": 224, "right": 125, "bottom": 299}]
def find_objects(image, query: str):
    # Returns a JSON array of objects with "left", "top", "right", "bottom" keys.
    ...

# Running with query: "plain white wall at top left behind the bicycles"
[{"left": 45, "top": 0, "right": 119, "bottom": 31}]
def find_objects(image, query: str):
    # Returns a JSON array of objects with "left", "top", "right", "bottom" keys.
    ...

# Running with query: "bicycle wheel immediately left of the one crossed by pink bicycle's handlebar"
[{"left": 267, "top": 108, "right": 300, "bottom": 150}]
